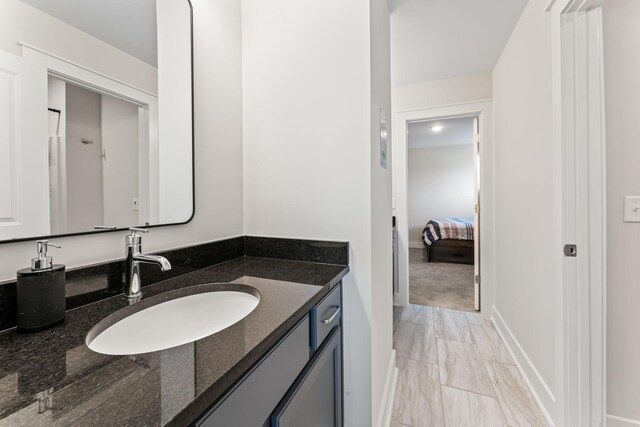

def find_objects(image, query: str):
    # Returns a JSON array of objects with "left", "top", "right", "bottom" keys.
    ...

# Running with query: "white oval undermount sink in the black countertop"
[{"left": 86, "top": 285, "right": 260, "bottom": 355}]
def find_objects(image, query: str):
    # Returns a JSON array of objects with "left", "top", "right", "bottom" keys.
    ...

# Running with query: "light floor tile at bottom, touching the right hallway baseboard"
[{"left": 485, "top": 361, "right": 548, "bottom": 427}]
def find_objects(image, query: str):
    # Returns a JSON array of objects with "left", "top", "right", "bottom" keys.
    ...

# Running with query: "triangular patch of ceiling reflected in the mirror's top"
[{"left": 22, "top": 0, "right": 158, "bottom": 67}]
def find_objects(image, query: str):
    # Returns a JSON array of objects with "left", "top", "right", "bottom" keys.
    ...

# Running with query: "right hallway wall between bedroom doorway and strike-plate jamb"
[{"left": 493, "top": 0, "right": 563, "bottom": 420}]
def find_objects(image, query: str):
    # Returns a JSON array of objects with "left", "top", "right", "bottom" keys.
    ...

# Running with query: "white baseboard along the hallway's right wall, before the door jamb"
[{"left": 491, "top": 306, "right": 556, "bottom": 426}]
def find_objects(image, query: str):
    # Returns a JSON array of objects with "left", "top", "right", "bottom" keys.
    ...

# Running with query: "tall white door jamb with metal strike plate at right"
[{"left": 556, "top": 6, "right": 604, "bottom": 426}]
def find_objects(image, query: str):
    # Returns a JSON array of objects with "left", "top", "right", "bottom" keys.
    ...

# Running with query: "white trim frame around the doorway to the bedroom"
[{"left": 392, "top": 99, "right": 494, "bottom": 314}]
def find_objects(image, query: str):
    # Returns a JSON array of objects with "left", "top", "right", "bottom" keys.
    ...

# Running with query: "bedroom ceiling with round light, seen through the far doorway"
[{"left": 408, "top": 117, "right": 473, "bottom": 149}]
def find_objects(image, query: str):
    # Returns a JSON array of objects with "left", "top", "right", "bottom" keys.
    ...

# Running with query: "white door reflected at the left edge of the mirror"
[{"left": 0, "top": 50, "right": 50, "bottom": 240}]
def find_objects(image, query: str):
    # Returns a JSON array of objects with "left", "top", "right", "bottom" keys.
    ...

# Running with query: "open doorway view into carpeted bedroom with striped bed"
[{"left": 407, "top": 116, "right": 480, "bottom": 311}]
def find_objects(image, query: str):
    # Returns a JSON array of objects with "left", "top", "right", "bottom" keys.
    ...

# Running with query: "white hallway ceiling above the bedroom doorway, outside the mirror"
[{"left": 389, "top": 0, "right": 527, "bottom": 86}]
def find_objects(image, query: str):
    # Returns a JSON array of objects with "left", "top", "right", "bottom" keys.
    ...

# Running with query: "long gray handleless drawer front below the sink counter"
[{"left": 195, "top": 316, "right": 309, "bottom": 427}]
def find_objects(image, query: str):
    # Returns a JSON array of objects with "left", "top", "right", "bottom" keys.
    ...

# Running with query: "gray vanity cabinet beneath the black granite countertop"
[{"left": 194, "top": 284, "right": 343, "bottom": 427}]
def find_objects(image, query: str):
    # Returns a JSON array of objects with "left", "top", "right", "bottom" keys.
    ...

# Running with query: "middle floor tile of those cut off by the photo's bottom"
[{"left": 442, "top": 386, "right": 506, "bottom": 427}]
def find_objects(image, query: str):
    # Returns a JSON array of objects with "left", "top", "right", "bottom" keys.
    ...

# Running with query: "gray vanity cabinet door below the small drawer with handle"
[{"left": 271, "top": 327, "right": 342, "bottom": 427}]
